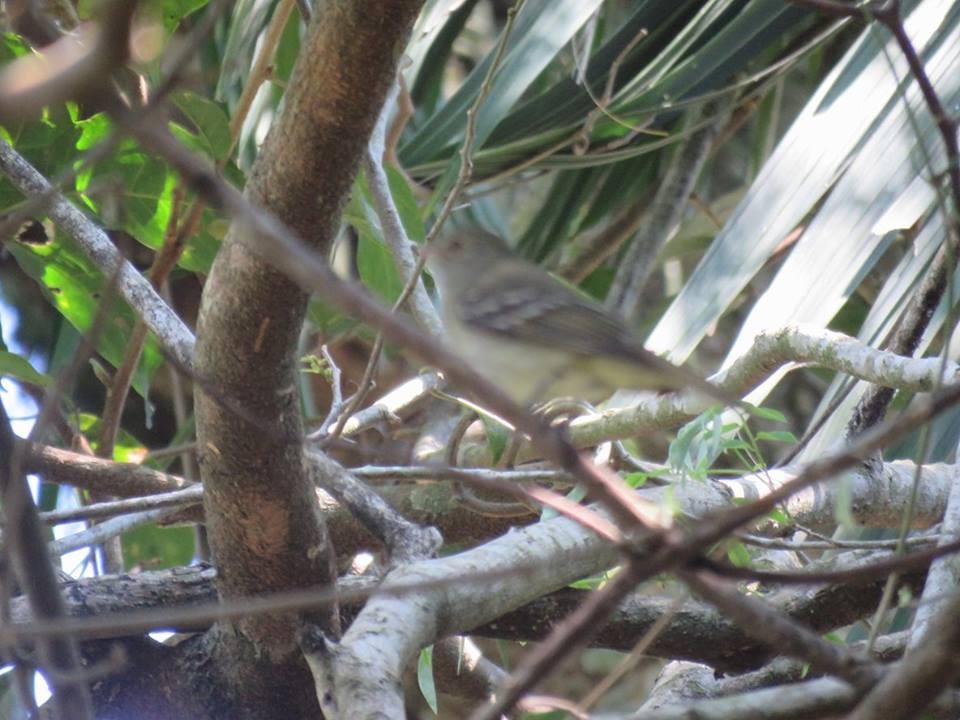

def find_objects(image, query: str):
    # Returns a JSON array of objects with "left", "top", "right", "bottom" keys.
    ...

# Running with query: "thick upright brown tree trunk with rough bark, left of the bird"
[{"left": 195, "top": 0, "right": 420, "bottom": 717}]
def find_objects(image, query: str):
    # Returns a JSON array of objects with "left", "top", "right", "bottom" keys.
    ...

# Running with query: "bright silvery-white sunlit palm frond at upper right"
[{"left": 648, "top": 0, "right": 960, "bottom": 372}]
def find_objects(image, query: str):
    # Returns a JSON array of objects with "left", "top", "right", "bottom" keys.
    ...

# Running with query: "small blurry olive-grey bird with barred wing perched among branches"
[{"left": 425, "top": 230, "right": 736, "bottom": 404}]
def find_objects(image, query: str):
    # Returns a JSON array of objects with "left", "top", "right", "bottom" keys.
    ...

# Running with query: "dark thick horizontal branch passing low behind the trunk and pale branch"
[{"left": 1, "top": 553, "right": 923, "bottom": 673}]
